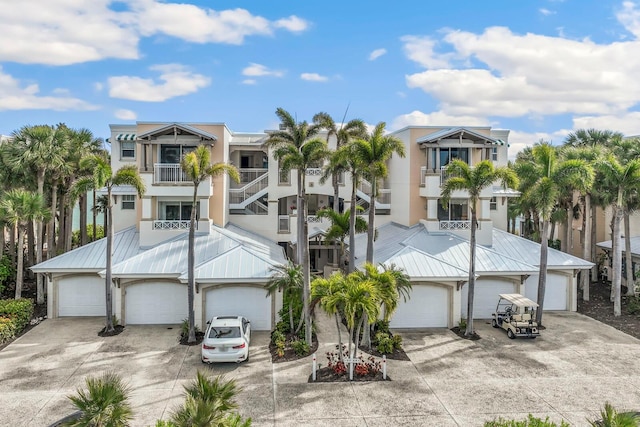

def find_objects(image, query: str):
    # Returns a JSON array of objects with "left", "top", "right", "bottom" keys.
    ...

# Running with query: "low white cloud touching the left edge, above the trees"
[{"left": 0, "top": 67, "right": 98, "bottom": 111}]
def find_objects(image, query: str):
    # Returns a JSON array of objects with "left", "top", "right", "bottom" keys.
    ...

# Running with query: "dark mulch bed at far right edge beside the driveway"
[{"left": 578, "top": 282, "right": 640, "bottom": 339}]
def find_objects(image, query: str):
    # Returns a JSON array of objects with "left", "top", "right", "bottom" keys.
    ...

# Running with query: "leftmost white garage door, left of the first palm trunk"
[{"left": 58, "top": 275, "right": 107, "bottom": 317}]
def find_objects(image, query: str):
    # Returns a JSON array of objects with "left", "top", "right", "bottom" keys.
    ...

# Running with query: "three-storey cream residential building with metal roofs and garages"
[{"left": 34, "top": 122, "right": 592, "bottom": 329}]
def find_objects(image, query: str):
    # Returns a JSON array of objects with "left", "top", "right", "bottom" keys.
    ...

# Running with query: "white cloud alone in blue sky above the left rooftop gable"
[{"left": 108, "top": 64, "right": 211, "bottom": 102}]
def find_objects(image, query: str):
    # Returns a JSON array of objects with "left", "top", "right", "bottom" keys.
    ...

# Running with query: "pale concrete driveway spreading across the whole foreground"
[{"left": 0, "top": 313, "right": 640, "bottom": 426}]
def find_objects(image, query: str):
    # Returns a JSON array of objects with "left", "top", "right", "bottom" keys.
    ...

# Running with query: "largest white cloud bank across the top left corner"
[{"left": 0, "top": 0, "right": 309, "bottom": 65}]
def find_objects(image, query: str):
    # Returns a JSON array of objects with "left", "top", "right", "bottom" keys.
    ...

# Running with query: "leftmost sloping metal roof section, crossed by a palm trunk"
[{"left": 31, "top": 227, "right": 142, "bottom": 273}]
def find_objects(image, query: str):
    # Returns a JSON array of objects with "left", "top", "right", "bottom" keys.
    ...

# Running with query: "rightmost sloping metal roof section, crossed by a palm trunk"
[{"left": 491, "top": 228, "right": 594, "bottom": 269}]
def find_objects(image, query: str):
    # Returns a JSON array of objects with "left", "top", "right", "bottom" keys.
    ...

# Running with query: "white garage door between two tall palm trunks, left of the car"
[{"left": 124, "top": 282, "right": 189, "bottom": 325}]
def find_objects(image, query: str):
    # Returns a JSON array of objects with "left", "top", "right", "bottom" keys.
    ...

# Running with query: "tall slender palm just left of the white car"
[{"left": 180, "top": 145, "right": 240, "bottom": 343}]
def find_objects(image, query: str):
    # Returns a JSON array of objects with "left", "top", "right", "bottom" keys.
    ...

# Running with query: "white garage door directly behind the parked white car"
[{"left": 205, "top": 286, "right": 271, "bottom": 331}]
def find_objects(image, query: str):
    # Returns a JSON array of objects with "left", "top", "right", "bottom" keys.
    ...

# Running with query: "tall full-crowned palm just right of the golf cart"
[{"left": 516, "top": 141, "right": 594, "bottom": 325}]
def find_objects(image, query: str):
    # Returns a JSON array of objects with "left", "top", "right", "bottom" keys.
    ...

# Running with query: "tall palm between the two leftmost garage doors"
[{"left": 75, "top": 154, "right": 146, "bottom": 334}]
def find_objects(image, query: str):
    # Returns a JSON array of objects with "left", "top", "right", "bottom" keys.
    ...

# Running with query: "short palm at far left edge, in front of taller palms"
[{"left": 0, "top": 189, "right": 49, "bottom": 299}]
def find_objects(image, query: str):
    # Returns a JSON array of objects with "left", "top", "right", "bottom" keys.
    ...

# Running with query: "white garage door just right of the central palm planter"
[{"left": 389, "top": 284, "right": 449, "bottom": 328}]
